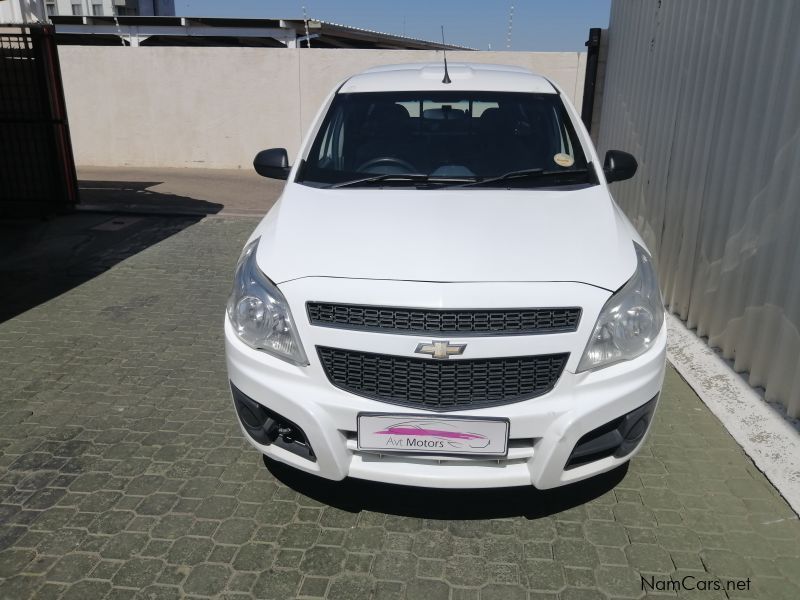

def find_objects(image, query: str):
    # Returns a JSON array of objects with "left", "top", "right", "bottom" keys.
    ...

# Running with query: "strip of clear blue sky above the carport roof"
[{"left": 175, "top": 0, "right": 611, "bottom": 52}]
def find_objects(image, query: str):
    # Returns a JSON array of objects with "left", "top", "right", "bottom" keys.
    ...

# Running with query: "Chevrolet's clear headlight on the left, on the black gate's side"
[{"left": 228, "top": 238, "right": 308, "bottom": 366}]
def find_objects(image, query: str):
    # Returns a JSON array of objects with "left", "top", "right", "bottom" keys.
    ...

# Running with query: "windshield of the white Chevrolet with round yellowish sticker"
[{"left": 297, "top": 92, "right": 593, "bottom": 187}]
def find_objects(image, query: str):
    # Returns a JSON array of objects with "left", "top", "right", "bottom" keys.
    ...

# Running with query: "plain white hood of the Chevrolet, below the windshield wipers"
[{"left": 253, "top": 183, "right": 636, "bottom": 290}]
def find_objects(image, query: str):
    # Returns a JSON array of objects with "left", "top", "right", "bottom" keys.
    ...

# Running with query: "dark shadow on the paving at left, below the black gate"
[{"left": 0, "top": 181, "right": 222, "bottom": 323}]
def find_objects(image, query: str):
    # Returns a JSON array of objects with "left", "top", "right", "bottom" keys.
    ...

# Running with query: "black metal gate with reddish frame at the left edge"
[{"left": 0, "top": 25, "right": 78, "bottom": 216}]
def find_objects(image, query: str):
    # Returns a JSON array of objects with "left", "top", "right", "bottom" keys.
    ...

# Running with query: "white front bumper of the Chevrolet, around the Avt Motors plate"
[{"left": 225, "top": 318, "right": 667, "bottom": 489}]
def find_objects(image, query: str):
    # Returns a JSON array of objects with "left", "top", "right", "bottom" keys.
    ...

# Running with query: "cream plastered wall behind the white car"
[{"left": 58, "top": 46, "right": 586, "bottom": 168}]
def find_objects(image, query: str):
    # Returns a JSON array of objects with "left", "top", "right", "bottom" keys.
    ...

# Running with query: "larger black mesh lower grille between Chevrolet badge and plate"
[{"left": 317, "top": 346, "right": 569, "bottom": 411}]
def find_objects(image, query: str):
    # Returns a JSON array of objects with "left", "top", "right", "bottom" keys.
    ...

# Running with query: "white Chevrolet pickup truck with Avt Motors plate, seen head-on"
[{"left": 225, "top": 64, "right": 666, "bottom": 488}]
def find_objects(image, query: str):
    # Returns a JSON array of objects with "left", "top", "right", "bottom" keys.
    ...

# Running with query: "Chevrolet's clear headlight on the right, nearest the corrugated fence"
[{"left": 578, "top": 243, "right": 664, "bottom": 373}]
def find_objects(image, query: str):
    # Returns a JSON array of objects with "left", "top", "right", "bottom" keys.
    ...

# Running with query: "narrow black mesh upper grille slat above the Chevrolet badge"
[{"left": 306, "top": 302, "right": 581, "bottom": 336}]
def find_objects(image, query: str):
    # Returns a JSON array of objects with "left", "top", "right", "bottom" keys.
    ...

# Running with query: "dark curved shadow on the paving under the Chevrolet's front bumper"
[{"left": 264, "top": 456, "right": 628, "bottom": 520}]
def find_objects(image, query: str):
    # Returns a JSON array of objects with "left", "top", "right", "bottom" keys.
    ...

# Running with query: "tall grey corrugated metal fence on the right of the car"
[{"left": 598, "top": 0, "right": 800, "bottom": 416}]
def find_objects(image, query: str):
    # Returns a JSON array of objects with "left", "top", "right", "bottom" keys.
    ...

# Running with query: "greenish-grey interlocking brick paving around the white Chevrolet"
[{"left": 0, "top": 218, "right": 800, "bottom": 600}]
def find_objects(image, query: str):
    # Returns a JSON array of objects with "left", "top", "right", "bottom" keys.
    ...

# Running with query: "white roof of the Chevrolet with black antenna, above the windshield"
[{"left": 339, "top": 62, "right": 558, "bottom": 94}]
